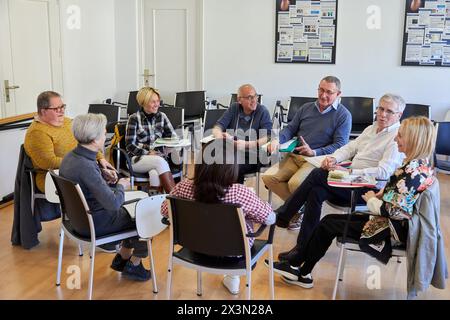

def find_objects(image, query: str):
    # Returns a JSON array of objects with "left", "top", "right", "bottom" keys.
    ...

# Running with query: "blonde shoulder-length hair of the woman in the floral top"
[{"left": 398, "top": 117, "right": 436, "bottom": 163}]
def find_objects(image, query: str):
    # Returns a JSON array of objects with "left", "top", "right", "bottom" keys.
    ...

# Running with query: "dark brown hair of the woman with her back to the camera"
[{"left": 194, "top": 139, "right": 239, "bottom": 203}]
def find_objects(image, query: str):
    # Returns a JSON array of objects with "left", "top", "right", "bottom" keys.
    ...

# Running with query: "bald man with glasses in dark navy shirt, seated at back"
[{"left": 213, "top": 84, "right": 272, "bottom": 183}]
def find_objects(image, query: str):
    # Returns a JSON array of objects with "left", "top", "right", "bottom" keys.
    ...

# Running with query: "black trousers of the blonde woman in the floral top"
[{"left": 289, "top": 214, "right": 369, "bottom": 275}]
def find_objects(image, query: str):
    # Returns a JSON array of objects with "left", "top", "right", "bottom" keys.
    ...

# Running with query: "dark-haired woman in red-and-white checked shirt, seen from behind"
[{"left": 161, "top": 139, "right": 275, "bottom": 294}]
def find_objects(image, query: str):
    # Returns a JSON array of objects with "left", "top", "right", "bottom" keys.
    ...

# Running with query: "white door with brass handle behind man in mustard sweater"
[{"left": 0, "top": 0, "right": 62, "bottom": 117}]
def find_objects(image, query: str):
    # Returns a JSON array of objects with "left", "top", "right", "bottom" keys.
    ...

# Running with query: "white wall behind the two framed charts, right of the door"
[{"left": 204, "top": 0, "right": 450, "bottom": 120}]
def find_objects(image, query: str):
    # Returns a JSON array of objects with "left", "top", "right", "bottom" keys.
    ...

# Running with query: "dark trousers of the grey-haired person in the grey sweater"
[{"left": 93, "top": 208, "right": 148, "bottom": 258}]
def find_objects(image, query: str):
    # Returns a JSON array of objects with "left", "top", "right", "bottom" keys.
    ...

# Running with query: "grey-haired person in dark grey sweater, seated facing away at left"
[{"left": 59, "top": 113, "right": 150, "bottom": 281}]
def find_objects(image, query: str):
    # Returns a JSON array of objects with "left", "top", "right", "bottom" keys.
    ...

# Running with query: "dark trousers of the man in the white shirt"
[{"left": 275, "top": 168, "right": 369, "bottom": 258}]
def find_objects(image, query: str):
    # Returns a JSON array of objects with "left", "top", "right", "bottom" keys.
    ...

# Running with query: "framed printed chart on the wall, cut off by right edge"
[{"left": 402, "top": 0, "right": 450, "bottom": 67}]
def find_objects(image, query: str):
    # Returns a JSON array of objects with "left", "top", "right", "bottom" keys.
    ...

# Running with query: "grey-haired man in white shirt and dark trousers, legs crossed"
[{"left": 275, "top": 94, "right": 405, "bottom": 259}]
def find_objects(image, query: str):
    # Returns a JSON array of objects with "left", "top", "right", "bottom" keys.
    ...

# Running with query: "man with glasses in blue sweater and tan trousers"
[{"left": 262, "top": 76, "right": 352, "bottom": 230}]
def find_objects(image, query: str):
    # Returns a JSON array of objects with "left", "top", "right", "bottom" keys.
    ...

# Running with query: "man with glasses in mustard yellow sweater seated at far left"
[{"left": 24, "top": 91, "right": 115, "bottom": 193}]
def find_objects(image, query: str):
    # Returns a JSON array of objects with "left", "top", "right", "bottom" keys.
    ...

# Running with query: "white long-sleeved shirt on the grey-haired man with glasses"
[{"left": 332, "top": 122, "right": 405, "bottom": 180}]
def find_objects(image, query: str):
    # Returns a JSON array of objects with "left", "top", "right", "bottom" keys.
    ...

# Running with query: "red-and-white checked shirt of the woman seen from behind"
[{"left": 161, "top": 179, "right": 272, "bottom": 246}]
